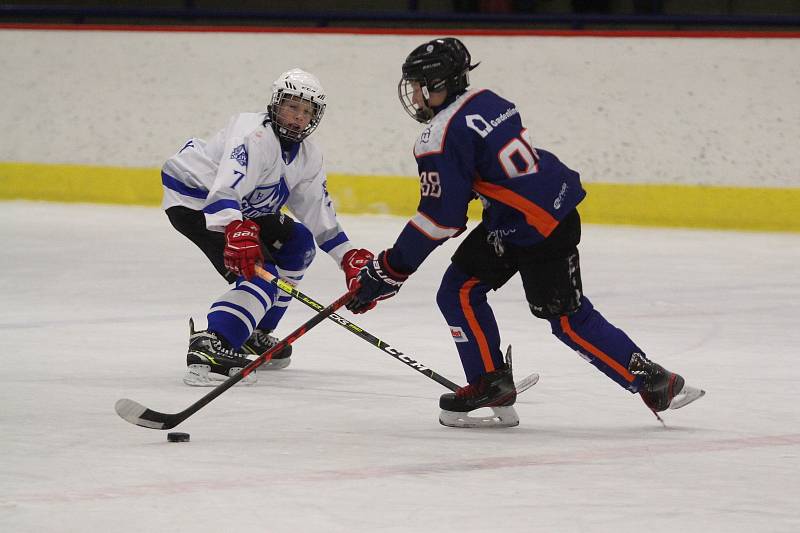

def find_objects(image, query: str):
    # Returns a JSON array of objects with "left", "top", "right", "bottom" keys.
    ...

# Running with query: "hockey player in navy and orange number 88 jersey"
[{"left": 348, "top": 38, "right": 703, "bottom": 427}]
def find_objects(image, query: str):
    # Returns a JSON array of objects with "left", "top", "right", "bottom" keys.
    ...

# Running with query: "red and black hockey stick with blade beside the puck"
[{"left": 114, "top": 286, "right": 353, "bottom": 429}]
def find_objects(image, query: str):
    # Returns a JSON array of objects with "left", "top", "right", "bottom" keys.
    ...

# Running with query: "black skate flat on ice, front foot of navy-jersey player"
[{"left": 439, "top": 346, "right": 519, "bottom": 428}]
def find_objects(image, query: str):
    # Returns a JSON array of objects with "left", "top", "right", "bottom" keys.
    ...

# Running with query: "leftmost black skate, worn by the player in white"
[{"left": 183, "top": 319, "right": 258, "bottom": 387}]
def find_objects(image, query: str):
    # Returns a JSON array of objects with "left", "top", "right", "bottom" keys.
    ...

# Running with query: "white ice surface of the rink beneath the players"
[{"left": 0, "top": 202, "right": 800, "bottom": 533}]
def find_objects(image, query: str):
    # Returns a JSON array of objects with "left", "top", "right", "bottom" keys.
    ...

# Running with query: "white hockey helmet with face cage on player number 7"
[{"left": 267, "top": 68, "right": 326, "bottom": 142}]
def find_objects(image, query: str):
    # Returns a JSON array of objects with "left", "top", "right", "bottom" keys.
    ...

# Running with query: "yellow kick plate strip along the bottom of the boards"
[{"left": 0, "top": 163, "right": 800, "bottom": 232}]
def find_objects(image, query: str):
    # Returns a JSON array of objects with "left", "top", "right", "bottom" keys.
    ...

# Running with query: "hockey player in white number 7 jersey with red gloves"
[{"left": 161, "top": 69, "right": 372, "bottom": 386}]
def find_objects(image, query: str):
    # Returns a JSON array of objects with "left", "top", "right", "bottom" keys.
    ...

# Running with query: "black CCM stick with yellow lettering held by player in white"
[{"left": 256, "top": 266, "right": 539, "bottom": 392}]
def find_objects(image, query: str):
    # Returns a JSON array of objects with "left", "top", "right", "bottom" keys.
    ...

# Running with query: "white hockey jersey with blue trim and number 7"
[{"left": 161, "top": 113, "right": 353, "bottom": 265}]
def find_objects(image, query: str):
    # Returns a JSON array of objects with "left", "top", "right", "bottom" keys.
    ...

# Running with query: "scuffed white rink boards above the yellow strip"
[{"left": 0, "top": 30, "right": 800, "bottom": 187}]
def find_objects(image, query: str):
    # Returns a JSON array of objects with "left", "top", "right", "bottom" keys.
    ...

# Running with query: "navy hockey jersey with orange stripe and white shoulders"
[{"left": 390, "top": 90, "right": 586, "bottom": 272}]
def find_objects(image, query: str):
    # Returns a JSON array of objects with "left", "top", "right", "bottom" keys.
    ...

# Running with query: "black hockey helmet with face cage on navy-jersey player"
[{"left": 397, "top": 37, "right": 478, "bottom": 123}]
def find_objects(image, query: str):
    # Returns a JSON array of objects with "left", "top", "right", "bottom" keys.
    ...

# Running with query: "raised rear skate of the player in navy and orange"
[{"left": 628, "top": 353, "right": 706, "bottom": 416}]
